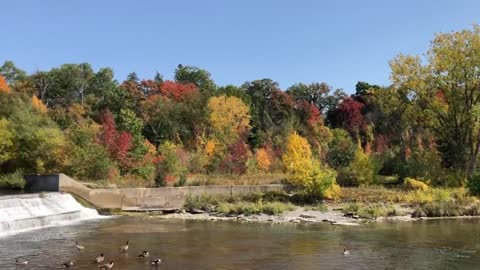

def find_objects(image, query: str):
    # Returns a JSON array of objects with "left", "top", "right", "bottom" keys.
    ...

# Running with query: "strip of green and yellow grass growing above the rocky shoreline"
[{"left": 185, "top": 186, "right": 480, "bottom": 219}]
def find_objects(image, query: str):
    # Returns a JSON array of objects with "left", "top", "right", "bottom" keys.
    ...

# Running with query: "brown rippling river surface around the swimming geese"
[{"left": 0, "top": 217, "right": 480, "bottom": 270}]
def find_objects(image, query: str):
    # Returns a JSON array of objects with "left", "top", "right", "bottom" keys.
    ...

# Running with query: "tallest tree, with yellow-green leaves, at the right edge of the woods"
[{"left": 390, "top": 25, "right": 480, "bottom": 175}]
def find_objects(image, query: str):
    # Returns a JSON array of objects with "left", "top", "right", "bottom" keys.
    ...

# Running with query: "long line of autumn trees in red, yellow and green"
[{"left": 0, "top": 25, "right": 480, "bottom": 192}]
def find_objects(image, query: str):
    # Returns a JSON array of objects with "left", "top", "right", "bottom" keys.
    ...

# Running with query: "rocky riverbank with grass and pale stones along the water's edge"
[{"left": 120, "top": 187, "right": 480, "bottom": 226}]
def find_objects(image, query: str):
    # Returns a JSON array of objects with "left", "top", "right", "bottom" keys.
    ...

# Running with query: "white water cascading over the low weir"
[{"left": 0, "top": 193, "right": 101, "bottom": 236}]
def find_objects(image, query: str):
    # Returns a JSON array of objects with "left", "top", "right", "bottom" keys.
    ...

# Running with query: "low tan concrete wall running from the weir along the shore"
[{"left": 25, "top": 174, "right": 283, "bottom": 211}]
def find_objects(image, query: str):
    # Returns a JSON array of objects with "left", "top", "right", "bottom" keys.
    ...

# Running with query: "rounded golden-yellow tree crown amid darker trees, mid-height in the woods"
[{"left": 208, "top": 96, "right": 250, "bottom": 144}]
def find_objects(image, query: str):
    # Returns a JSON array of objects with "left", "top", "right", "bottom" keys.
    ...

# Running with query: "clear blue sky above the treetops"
[{"left": 0, "top": 0, "right": 480, "bottom": 93}]
